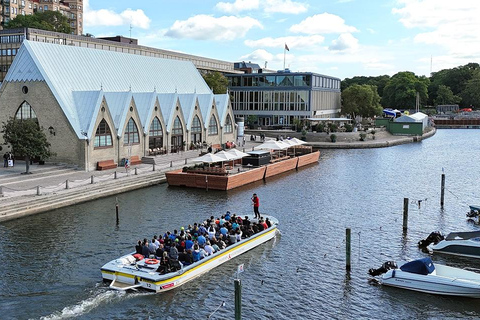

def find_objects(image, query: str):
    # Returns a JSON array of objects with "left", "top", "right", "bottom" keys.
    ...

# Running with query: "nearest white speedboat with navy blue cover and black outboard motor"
[{"left": 381, "top": 258, "right": 480, "bottom": 298}]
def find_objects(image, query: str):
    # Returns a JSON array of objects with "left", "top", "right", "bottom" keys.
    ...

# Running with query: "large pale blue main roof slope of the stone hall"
[{"left": 5, "top": 40, "right": 211, "bottom": 138}]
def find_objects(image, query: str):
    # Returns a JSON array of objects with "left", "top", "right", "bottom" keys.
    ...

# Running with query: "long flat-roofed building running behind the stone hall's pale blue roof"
[{"left": 0, "top": 27, "right": 234, "bottom": 82}]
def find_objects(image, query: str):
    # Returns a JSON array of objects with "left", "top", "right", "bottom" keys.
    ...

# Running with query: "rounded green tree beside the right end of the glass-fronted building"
[{"left": 342, "top": 84, "right": 382, "bottom": 118}]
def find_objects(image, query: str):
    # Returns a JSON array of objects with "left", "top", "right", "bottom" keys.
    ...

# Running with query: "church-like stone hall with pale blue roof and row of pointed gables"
[{"left": 0, "top": 40, "right": 236, "bottom": 170}]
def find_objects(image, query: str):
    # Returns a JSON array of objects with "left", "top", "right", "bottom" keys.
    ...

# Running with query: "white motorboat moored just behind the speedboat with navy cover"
[{"left": 430, "top": 231, "right": 480, "bottom": 258}]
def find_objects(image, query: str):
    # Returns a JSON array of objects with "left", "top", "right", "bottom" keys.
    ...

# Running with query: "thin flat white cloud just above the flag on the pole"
[{"left": 245, "top": 35, "right": 325, "bottom": 50}]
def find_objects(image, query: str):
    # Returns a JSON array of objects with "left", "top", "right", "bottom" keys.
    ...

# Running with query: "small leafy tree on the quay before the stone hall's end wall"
[{"left": 2, "top": 118, "right": 54, "bottom": 173}]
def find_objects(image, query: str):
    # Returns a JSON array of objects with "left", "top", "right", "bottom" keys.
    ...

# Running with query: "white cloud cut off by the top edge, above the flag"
[{"left": 215, "top": 0, "right": 308, "bottom": 14}]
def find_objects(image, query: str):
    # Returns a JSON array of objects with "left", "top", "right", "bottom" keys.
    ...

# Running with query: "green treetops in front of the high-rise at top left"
[{"left": 5, "top": 10, "right": 72, "bottom": 33}]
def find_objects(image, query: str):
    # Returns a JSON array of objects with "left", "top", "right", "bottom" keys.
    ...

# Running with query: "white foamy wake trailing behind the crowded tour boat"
[{"left": 40, "top": 288, "right": 153, "bottom": 320}]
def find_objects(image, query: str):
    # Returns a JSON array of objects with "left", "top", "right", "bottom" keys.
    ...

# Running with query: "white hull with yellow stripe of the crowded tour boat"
[{"left": 101, "top": 215, "right": 278, "bottom": 292}]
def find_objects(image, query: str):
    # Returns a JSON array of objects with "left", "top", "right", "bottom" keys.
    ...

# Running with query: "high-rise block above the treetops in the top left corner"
[{"left": 0, "top": 0, "right": 83, "bottom": 35}]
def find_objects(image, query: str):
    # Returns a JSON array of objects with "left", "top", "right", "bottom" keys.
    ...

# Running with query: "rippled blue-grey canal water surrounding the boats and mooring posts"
[{"left": 0, "top": 130, "right": 480, "bottom": 319}]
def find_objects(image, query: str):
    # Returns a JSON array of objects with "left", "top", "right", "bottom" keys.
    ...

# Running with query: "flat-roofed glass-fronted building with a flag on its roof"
[{"left": 227, "top": 70, "right": 341, "bottom": 128}]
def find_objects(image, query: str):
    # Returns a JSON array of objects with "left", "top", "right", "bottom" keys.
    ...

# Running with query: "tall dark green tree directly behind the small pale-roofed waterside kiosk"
[{"left": 382, "top": 71, "right": 430, "bottom": 109}]
